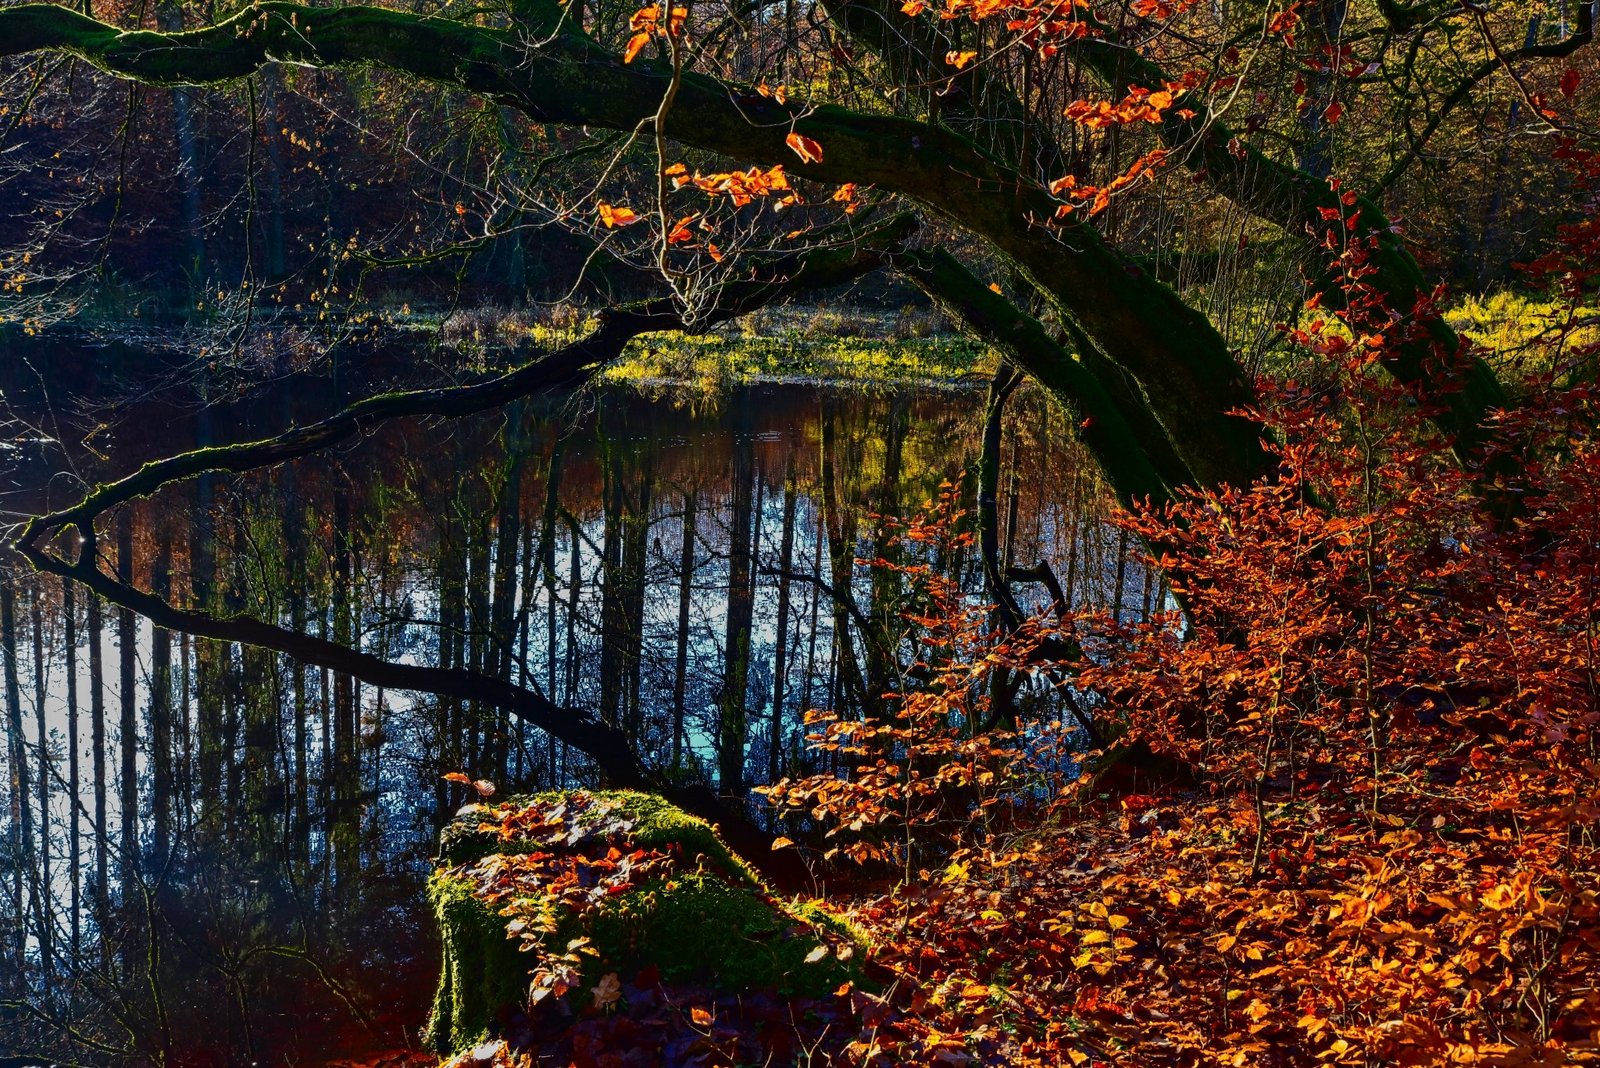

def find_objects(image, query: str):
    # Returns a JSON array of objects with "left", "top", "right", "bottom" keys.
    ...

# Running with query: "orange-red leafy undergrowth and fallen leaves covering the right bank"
[{"left": 425, "top": 191, "right": 1600, "bottom": 1065}]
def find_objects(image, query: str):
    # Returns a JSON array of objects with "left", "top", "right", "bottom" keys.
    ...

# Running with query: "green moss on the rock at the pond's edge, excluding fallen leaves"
[{"left": 427, "top": 791, "right": 866, "bottom": 1052}]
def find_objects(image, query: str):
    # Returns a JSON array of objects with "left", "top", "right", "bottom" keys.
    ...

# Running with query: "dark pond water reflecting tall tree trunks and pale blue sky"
[{"left": 0, "top": 374, "right": 1166, "bottom": 1065}]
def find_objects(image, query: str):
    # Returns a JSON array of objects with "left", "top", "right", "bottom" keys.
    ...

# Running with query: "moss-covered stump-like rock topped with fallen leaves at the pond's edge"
[{"left": 429, "top": 791, "right": 864, "bottom": 1052}]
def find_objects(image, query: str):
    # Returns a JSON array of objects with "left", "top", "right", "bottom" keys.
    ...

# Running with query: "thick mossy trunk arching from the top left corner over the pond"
[{"left": 0, "top": 0, "right": 1272, "bottom": 484}]
